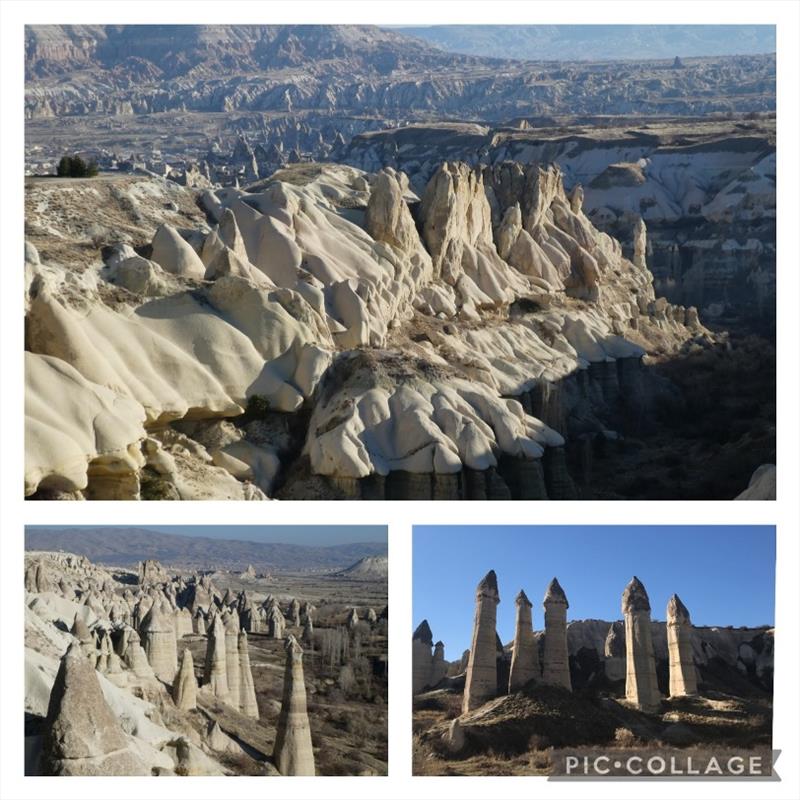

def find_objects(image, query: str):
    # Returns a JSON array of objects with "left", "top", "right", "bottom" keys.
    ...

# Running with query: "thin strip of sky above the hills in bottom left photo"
[{"left": 28, "top": 525, "right": 386, "bottom": 547}]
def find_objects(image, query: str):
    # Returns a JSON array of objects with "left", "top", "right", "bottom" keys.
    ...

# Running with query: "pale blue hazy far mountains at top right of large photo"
[{"left": 393, "top": 25, "right": 775, "bottom": 61}]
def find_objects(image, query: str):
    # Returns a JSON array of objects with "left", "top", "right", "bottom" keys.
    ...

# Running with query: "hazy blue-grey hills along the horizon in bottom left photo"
[{"left": 25, "top": 527, "right": 387, "bottom": 572}]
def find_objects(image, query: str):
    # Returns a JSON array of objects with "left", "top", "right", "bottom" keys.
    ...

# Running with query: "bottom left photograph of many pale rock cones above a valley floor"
[{"left": 24, "top": 526, "right": 389, "bottom": 776}]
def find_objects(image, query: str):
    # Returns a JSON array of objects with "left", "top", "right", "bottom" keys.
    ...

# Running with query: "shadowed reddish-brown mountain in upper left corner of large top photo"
[{"left": 25, "top": 25, "right": 488, "bottom": 81}]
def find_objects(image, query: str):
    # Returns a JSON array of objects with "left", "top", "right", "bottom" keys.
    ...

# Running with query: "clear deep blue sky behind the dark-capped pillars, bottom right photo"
[{"left": 413, "top": 525, "right": 775, "bottom": 659}]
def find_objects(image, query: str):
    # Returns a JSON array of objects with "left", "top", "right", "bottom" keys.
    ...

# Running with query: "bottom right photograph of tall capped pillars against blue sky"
[{"left": 411, "top": 525, "right": 780, "bottom": 780}]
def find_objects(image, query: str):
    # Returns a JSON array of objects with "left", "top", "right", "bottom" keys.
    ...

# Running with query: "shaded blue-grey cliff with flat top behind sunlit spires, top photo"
[{"left": 342, "top": 119, "right": 776, "bottom": 325}]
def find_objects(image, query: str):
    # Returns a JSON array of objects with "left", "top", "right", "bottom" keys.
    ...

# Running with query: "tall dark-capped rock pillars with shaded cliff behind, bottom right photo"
[{"left": 424, "top": 571, "right": 736, "bottom": 720}]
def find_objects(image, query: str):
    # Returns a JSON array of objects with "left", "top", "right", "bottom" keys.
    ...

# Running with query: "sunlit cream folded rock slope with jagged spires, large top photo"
[{"left": 26, "top": 156, "right": 724, "bottom": 499}]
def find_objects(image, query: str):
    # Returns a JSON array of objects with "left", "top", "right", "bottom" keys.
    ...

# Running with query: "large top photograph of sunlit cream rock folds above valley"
[{"left": 24, "top": 25, "right": 778, "bottom": 500}]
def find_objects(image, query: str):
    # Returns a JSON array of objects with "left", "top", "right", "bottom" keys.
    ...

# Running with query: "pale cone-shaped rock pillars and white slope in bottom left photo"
[{"left": 25, "top": 551, "right": 380, "bottom": 775}]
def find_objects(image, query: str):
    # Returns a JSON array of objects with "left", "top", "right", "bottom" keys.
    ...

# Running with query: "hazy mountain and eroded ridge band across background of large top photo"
[{"left": 26, "top": 25, "right": 775, "bottom": 120}]
